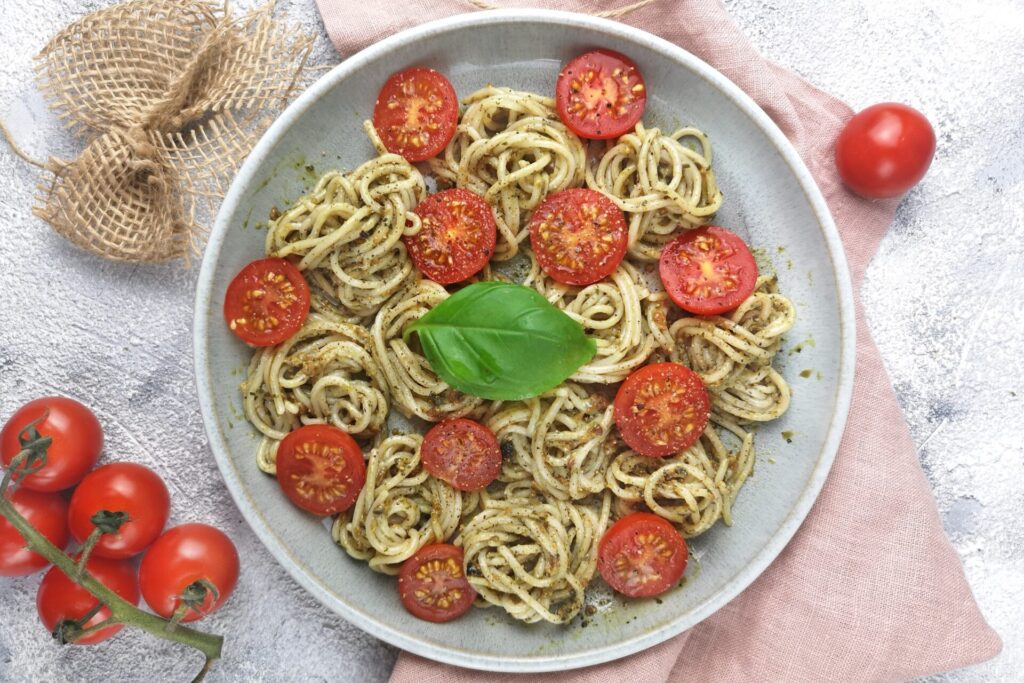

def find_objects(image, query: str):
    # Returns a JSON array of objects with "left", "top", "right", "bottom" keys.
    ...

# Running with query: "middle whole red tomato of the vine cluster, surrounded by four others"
[{"left": 68, "top": 463, "right": 171, "bottom": 559}]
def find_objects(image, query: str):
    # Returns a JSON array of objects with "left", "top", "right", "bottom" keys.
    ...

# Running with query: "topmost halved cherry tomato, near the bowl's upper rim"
[{"left": 555, "top": 50, "right": 647, "bottom": 140}]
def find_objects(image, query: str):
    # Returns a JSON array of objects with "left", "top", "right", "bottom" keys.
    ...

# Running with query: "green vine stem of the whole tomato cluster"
[{"left": 0, "top": 448, "right": 224, "bottom": 681}]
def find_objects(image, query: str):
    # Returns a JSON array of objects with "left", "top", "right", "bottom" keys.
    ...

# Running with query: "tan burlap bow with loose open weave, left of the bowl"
[{"left": 34, "top": 0, "right": 312, "bottom": 261}]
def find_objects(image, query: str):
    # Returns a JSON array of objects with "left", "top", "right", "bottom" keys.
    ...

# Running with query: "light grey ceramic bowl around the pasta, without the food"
[{"left": 195, "top": 10, "right": 854, "bottom": 672}]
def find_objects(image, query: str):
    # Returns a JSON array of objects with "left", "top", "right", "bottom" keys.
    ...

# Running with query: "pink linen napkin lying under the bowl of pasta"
[{"left": 316, "top": 0, "right": 1001, "bottom": 683}]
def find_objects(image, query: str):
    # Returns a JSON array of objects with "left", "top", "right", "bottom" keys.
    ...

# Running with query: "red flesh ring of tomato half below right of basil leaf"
[{"left": 613, "top": 362, "right": 711, "bottom": 458}]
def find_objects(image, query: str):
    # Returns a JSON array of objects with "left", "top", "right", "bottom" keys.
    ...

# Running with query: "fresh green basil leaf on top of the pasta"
[{"left": 404, "top": 282, "right": 597, "bottom": 400}]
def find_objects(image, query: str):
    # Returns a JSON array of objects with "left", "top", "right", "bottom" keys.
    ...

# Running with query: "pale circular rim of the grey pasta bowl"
[{"left": 193, "top": 9, "right": 856, "bottom": 673}]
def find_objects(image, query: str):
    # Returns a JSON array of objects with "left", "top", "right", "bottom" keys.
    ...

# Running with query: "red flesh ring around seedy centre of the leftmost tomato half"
[{"left": 223, "top": 257, "right": 309, "bottom": 348}]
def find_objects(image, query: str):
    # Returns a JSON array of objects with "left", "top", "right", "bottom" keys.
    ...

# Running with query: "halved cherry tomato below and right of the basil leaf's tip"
[{"left": 614, "top": 362, "right": 711, "bottom": 458}]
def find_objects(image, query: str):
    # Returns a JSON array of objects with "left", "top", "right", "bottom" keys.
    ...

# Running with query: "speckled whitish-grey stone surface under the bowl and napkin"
[{"left": 0, "top": 0, "right": 1024, "bottom": 682}]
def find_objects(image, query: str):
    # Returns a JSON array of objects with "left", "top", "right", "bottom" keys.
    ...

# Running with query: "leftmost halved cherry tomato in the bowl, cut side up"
[{"left": 224, "top": 258, "right": 309, "bottom": 346}]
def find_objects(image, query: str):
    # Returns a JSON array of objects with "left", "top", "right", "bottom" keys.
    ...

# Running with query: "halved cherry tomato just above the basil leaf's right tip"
[{"left": 529, "top": 187, "right": 629, "bottom": 286}]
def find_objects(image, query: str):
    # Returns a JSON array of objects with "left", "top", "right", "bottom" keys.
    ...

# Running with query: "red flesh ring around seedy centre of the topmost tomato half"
[{"left": 555, "top": 49, "right": 647, "bottom": 140}]
